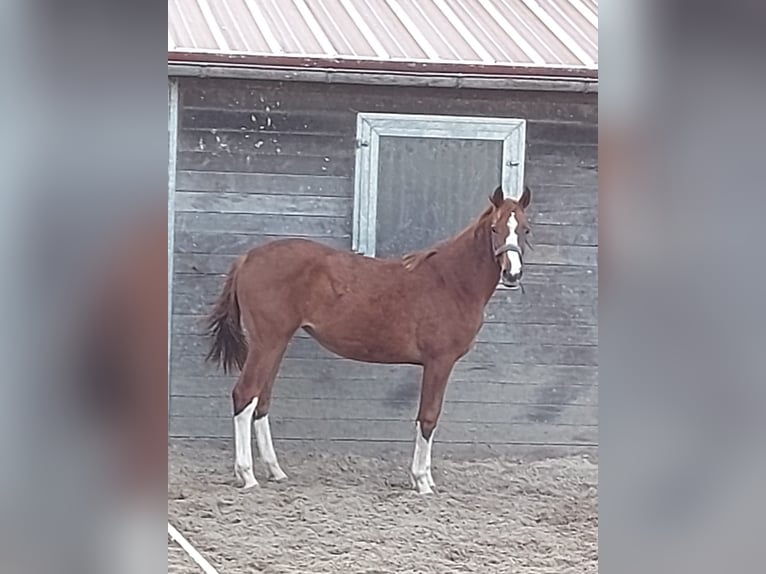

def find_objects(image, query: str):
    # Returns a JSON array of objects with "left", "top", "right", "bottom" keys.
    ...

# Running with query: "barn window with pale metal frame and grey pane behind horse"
[{"left": 352, "top": 113, "right": 526, "bottom": 257}]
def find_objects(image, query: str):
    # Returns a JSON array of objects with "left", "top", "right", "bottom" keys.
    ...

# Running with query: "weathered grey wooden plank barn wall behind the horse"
[{"left": 170, "top": 79, "right": 598, "bottom": 452}]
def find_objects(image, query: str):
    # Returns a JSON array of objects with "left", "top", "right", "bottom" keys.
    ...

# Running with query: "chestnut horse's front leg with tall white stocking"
[{"left": 410, "top": 358, "right": 455, "bottom": 494}]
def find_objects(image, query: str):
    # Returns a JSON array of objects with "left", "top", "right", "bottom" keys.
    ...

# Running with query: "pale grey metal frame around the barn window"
[{"left": 351, "top": 112, "right": 527, "bottom": 257}]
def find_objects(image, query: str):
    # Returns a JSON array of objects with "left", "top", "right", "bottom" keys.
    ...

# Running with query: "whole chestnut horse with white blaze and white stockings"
[{"left": 207, "top": 187, "right": 531, "bottom": 494}]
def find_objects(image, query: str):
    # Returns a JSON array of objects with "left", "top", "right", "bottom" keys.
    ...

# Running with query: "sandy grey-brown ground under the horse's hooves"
[{"left": 168, "top": 443, "right": 598, "bottom": 574}]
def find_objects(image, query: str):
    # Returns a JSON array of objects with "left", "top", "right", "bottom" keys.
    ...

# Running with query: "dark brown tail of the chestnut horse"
[{"left": 205, "top": 256, "right": 247, "bottom": 373}]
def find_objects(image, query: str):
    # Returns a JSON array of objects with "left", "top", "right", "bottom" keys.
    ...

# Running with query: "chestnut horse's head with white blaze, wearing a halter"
[{"left": 489, "top": 186, "right": 532, "bottom": 289}]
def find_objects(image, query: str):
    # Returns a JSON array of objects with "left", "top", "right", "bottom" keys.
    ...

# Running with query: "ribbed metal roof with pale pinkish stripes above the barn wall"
[{"left": 168, "top": 0, "right": 598, "bottom": 77}]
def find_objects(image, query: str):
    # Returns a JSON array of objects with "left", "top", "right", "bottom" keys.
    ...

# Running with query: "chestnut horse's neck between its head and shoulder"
[{"left": 442, "top": 222, "right": 500, "bottom": 306}]
